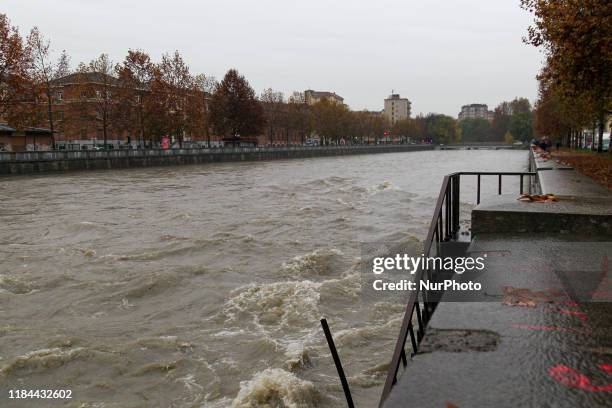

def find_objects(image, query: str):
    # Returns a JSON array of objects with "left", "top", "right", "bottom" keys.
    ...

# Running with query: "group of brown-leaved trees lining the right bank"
[{"left": 521, "top": 0, "right": 612, "bottom": 152}]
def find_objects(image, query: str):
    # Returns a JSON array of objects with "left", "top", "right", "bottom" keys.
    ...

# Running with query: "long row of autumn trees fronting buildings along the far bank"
[{"left": 0, "top": 14, "right": 533, "bottom": 150}]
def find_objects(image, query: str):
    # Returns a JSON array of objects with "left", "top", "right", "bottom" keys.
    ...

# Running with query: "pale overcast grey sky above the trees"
[{"left": 0, "top": 0, "right": 542, "bottom": 116}]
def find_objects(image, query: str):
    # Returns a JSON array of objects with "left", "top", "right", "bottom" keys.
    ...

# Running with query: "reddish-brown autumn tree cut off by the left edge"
[{"left": 0, "top": 14, "right": 31, "bottom": 126}]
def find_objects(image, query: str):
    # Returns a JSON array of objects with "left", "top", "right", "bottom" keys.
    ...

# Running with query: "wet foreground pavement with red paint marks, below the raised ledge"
[{"left": 384, "top": 235, "right": 612, "bottom": 408}]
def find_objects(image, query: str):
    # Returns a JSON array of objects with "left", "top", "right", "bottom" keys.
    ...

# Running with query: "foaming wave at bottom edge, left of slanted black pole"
[{"left": 231, "top": 368, "right": 319, "bottom": 408}]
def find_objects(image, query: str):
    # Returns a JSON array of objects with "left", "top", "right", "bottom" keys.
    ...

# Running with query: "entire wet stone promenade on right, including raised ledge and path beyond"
[{"left": 382, "top": 152, "right": 612, "bottom": 408}]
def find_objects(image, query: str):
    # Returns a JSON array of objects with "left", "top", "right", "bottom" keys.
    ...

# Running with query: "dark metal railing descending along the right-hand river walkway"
[{"left": 379, "top": 172, "right": 537, "bottom": 407}]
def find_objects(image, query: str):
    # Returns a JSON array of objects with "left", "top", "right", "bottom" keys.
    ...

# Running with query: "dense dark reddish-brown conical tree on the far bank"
[{"left": 210, "top": 69, "right": 265, "bottom": 136}]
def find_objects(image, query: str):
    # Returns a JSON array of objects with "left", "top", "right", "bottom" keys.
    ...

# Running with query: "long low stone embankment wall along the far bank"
[{"left": 0, "top": 145, "right": 434, "bottom": 175}]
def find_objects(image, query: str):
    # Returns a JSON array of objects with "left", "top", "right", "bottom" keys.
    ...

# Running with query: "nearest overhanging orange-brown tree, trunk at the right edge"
[{"left": 521, "top": 0, "right": 612, "bottom": 152}]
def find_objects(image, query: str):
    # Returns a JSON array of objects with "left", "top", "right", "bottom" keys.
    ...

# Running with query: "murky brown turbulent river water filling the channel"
[{"left": 0, "top": 150, "right": 527, "bottom": 408}]
